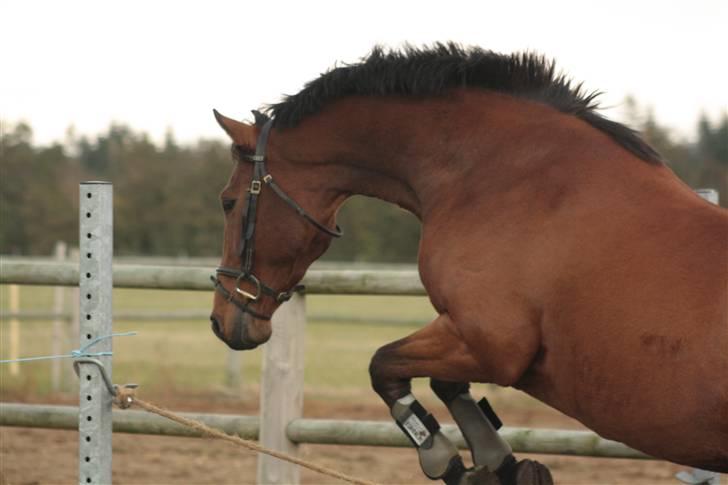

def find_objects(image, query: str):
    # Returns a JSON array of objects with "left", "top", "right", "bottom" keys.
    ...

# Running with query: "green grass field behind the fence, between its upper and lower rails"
[{"left": 0, "top": 286, "right": 450, "bottom": 395}]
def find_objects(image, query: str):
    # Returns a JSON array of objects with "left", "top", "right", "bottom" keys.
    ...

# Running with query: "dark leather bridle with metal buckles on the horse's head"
[{"left": 210, "top": 119, "right": 343, "bottom": 320}]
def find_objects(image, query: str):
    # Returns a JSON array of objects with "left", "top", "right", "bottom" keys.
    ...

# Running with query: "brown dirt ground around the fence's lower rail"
[{"left": 0, "top": 390, "right": 712, "bottom": 485}]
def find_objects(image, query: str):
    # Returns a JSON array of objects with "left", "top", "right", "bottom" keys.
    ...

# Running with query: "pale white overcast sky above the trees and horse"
[{"left": 0, "top": 0, "right": 728, "bottom": 143}]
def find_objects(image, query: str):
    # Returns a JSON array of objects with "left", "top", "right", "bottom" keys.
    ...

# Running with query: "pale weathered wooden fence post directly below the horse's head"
[{"left": 258, "top": 294, "right": 306, "bottom": 485}]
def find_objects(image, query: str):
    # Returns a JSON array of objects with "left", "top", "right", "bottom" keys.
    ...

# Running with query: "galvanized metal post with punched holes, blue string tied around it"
[{"left": 78, "top": 182, "right": 114, "bottom": 484}]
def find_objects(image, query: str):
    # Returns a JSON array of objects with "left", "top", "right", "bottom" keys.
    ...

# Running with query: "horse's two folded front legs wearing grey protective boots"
[{"left": 369, "top": 314, "right": 552, "bottom": 485}]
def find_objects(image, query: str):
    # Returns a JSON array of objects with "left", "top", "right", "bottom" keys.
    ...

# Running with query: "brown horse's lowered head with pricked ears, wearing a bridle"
[{"left": 210, "top": 111, "right": 341, "bottom": 350}]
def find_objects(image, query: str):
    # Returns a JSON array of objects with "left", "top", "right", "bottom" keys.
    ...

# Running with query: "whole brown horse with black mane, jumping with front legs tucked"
[{"left": 211, "top": 44, "right": 728, "bottom": 483}]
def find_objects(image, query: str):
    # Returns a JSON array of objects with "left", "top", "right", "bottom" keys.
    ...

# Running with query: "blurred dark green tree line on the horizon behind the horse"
[{"left": 0, "top": 99, "right": 728, "bottom": 262}]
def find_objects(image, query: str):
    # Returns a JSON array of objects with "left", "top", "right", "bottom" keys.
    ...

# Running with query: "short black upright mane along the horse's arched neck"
[{"left": 264, "top": 43, "right": 661, "bottom": 163}]
